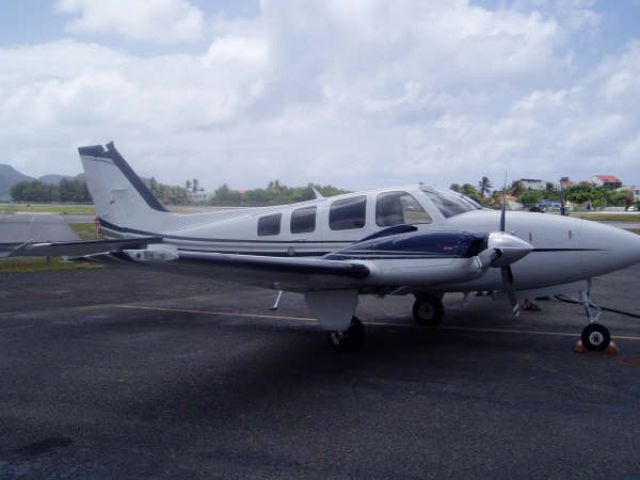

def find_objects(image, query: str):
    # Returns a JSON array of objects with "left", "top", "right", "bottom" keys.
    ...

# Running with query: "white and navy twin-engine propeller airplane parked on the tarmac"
[{"left": 5, "top": 143, "right": 640, "bottom": 350}]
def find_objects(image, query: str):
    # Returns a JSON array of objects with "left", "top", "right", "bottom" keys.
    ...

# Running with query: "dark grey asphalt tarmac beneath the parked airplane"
[{"left": 0, "top": 265, "right": 640, "bottom": 480}]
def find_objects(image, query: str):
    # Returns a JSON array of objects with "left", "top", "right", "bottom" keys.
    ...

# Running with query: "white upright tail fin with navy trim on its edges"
[{"left": 78, "top": 142, "right": 170, "bottom": 229}]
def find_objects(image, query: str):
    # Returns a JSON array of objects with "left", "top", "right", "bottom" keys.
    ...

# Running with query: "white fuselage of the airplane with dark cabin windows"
[{"left": 98, "top": 185, "right": 640, "bottom": 291}]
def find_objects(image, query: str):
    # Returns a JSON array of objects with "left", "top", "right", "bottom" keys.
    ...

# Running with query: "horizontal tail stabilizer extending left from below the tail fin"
[{"left": 0, "top": 237, "right": 162, "bottom": 258}]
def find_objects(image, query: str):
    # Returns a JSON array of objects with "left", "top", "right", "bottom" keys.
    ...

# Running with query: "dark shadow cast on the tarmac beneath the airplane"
[{"left": 81, "top": 308, "right": 596, "bottom": 423}]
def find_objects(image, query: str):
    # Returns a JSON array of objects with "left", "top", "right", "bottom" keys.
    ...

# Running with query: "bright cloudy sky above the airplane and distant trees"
[{"left": 0, "top": 0, "right": 640, "bottom": 191}]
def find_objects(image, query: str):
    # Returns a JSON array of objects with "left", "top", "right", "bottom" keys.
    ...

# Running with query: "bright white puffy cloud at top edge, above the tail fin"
[{"left": 56, "top": 0, "right": 204, "bottom": 43}]
